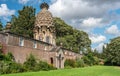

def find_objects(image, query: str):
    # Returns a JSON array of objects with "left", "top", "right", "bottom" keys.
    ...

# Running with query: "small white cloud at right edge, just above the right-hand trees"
[{"left": 105, "top": 25, "right": 120, "bottom": 36}]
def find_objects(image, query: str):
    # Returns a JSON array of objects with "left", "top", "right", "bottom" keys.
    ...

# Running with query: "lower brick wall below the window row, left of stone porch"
[{"left": 7, "top": 45, "right": 55, "bottom": 63}]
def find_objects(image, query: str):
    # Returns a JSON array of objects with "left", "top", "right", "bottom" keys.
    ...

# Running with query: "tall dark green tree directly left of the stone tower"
[{"left": 11, "top": 6, "right": 35, "bottom": 38}]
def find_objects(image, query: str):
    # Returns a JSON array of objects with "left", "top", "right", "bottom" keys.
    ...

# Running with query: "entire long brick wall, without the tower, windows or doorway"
[{"left": 0, "top": 33, "right": 82, "bottom": 67}]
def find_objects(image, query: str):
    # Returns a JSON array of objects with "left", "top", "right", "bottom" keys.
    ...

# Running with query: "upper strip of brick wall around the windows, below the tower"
[{"left": 7, "top": 34, "right": 53, "bottom": 50}]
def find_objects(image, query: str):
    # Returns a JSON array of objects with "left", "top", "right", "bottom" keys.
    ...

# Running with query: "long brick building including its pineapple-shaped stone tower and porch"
[{"left": 0, "top": 3, "right": 81, "bottom": 68}]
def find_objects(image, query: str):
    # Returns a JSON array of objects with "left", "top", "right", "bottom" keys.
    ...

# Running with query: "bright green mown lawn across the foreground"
[{"left": 1, "top": 66, "right": 120, "bottom": 76}]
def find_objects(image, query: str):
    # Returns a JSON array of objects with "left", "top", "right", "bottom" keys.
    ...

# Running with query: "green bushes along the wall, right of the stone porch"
[{"left": 64, "top": 49, "right": 102, "bottom": 68}]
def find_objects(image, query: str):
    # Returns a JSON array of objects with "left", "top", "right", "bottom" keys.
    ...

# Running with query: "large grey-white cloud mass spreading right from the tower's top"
[{"left": 49, "top": 0, "right": 120, "bottom": 31}]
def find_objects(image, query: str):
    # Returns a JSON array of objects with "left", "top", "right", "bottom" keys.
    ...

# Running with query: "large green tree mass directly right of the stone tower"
[{"left": 54, "top": 18, "right": 91, "bottom": 53}]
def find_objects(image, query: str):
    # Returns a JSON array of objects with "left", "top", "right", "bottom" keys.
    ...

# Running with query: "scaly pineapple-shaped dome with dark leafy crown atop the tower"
[{"left": 35, "top": 3, "right": 53, "bottom": 26}]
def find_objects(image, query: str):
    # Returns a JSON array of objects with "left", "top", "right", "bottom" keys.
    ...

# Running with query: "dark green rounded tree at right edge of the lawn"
[{"left": 103, "top": 37, "right": 120, "bottom": 66}]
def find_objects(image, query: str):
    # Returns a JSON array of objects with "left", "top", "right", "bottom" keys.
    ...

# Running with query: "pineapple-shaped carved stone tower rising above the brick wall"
[{"left": 34, "top": 2, "right": 56, "bottom": 45}]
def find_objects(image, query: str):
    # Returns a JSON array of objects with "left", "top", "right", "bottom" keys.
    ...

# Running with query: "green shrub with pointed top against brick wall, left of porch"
[{"left": 24, "top": 54, "right": 55, "bottom": 71}]
